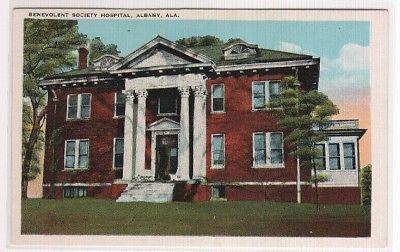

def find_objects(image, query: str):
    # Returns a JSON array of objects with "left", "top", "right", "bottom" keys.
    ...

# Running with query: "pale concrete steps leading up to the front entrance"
[{"left": 117, "top": 182, "right": 175, "bottom": 203}]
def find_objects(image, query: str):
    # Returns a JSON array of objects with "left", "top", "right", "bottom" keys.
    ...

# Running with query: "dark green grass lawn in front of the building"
[{"left": 22, "top": 198, "right": 371, "bottom": 237}]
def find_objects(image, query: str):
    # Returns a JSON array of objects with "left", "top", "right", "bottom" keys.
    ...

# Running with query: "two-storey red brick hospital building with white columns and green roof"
[{"left": 41, "top": 36, "right": 366, "bottom": 203}]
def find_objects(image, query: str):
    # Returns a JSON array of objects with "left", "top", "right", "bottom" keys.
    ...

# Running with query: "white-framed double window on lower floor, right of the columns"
[{"left": 252, "top": 131, "right": 285, "bottom": 169}]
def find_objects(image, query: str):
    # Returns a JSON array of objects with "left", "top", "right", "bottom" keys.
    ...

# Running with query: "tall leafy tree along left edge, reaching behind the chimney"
[{"left": 21, "top": 19, "right": 119, "bottom": 198}]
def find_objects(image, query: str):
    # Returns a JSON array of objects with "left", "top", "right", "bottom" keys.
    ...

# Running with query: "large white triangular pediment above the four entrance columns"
[{"left": 110, "top": 36, "right": 211, "bottom": 70}]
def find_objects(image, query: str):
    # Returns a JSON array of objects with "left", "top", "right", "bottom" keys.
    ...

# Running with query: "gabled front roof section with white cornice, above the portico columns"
[{"left": 110, "top": 36, "right": 212, "bottom": 70}]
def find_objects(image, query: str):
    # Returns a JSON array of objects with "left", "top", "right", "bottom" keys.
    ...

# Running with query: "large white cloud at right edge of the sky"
[{"left": 339, "top": 43, "right": 369, "bottom": 71}]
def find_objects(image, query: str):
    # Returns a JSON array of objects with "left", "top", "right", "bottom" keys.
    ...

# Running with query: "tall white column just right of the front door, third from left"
[{"left": 177, "top": 87, "right": 190, "bottom": 180}]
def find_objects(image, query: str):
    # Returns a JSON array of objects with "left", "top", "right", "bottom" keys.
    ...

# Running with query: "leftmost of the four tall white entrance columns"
[{"left": 122, "top": 90, "right": 135, "bottom": 181}]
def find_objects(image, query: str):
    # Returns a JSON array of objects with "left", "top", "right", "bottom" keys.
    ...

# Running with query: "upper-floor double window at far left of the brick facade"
[{"left": 67, "top": 94, "right": 92, "bottom": 119}]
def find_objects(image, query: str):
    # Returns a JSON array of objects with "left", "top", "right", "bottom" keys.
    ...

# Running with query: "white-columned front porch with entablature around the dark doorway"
[{"left": 122, "top": 74, "right": 206, "bottom": 183}]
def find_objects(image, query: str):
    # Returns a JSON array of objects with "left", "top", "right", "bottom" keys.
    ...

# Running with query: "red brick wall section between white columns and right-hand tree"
[{"left": 206, "top": 73, "right": 310, "bottom": 181}]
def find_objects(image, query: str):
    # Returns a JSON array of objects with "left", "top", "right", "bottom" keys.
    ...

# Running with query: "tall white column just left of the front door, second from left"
[{"left": 134, "top": 89, "right": 147, "bottom": 177}]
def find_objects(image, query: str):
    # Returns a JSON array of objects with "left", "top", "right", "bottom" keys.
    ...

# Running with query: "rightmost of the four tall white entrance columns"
[{"left": 193, "top": 85, "right": 207, "bottom": 179}]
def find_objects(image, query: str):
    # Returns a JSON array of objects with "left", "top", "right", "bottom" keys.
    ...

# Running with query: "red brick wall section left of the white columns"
[{"left": 43, "top": 83, "right": 124, "bottom": 184}]
